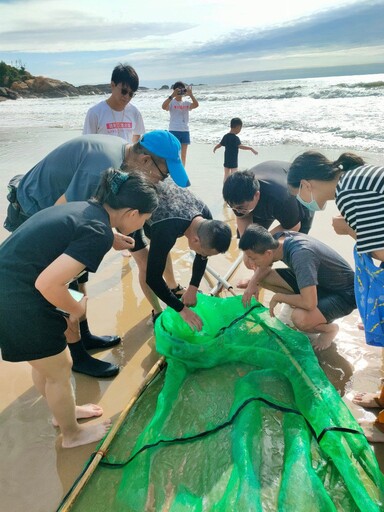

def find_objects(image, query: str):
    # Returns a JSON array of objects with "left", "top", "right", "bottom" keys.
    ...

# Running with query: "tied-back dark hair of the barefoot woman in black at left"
[{"left": 92, "top": 167, "right": 159, "bottom": 213}]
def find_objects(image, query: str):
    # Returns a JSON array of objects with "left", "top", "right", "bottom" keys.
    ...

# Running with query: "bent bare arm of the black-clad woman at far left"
[{"left": 35, "top": 254, "right": 87, "bottom": 318}]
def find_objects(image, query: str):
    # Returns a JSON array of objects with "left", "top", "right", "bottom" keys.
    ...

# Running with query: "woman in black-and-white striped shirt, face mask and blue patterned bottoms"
[{"left": 287, "top": 151, "right": 384, "bottom": 442}]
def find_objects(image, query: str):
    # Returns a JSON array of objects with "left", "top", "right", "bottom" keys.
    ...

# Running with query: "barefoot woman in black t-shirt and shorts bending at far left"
[{"left": 0, "top": 169, "right": 157, "bottom": 448}]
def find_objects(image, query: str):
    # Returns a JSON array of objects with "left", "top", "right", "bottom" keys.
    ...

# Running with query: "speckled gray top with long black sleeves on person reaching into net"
[{"left": 144, "top": 180, "right": 212, "bottom": 311}]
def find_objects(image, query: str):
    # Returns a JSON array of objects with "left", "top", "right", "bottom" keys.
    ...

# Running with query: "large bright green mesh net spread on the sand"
[{"left": 66, "top": 295, "right": 384, "bottom": 512}]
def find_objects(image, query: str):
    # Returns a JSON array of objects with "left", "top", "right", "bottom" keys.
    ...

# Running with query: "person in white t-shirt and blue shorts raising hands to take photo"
[{"left": 161, "top": 82, "right": 199, "bottom": 165}]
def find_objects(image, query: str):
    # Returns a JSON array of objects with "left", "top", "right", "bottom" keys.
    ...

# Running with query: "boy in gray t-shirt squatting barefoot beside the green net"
[{"left": 239, "top": 225, "right": 356, "bottom": 350}]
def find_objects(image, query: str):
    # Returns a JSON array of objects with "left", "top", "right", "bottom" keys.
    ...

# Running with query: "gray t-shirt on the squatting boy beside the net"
[{"left": 274, "top": 231, "right": 354, "bottom": 296}]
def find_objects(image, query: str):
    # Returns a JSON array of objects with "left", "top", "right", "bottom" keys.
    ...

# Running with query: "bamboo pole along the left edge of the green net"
[{"left": 57, "top": 357, "right": 166, "bottom": 512}]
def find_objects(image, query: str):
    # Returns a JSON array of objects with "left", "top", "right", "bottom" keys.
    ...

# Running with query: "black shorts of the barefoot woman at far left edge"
[{"left": 0, "top": 302, "right": 67, "bottom": 362}]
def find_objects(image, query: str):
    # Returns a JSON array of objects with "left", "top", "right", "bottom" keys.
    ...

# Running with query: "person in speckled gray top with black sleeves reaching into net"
[{"left": 144, "top": 182, "right": 231, "bottom": 330}]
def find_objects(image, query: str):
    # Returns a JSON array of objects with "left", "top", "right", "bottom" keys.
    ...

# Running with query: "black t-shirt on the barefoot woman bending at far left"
[{"left": 0, "top": 201, "right": 113, "bottom": 308}]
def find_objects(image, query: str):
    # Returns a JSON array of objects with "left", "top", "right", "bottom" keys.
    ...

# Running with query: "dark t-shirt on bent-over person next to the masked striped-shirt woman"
[{"left": 249, "top": 160, "right": 311, "bottom": 229}]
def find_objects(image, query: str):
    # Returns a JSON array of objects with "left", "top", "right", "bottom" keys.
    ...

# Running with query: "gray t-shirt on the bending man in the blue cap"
[{"left": 17, "top": 134, "right": 127, "bottom": 216}]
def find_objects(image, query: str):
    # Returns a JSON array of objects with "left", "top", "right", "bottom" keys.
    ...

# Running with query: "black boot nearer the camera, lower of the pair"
[{"left": 68, "top": 340, "right": 119, "bottom": 379}]
